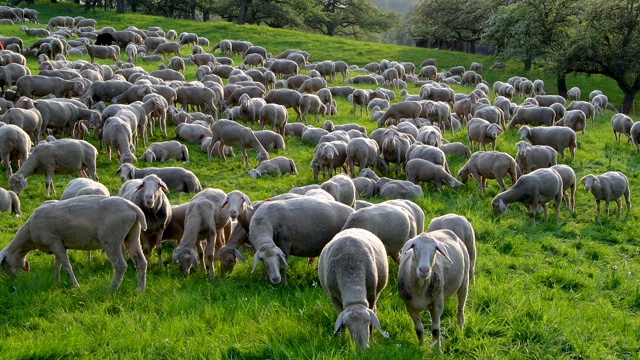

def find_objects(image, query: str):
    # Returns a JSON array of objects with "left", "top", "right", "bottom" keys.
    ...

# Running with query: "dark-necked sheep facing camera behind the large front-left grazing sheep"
[{"left": 118, "top": 176, "right": 171, "bottom": 266}]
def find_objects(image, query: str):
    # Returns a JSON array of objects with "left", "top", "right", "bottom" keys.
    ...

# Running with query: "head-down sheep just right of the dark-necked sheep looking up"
[{"left": 172, "top": 188, "right": 231, "bottom": 280}]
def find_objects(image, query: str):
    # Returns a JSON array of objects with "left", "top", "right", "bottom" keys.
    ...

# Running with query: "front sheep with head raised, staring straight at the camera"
[{"left": 398, "top": 229, "right": 470, "bottom": 352}]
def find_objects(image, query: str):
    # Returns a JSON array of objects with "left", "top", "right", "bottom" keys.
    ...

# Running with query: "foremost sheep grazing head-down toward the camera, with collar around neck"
[{"left": 318, "top": 229, "right": 389, "bottom": 349}]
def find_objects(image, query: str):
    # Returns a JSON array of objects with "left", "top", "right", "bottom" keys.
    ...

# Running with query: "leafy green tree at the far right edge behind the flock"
[{"left": 560, "top": 0, "right": 640, "bottom": 114}]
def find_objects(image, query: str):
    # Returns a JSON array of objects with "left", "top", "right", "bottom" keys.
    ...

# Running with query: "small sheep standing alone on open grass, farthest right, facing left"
[{"left": 580, "top": 171, "right": 631, "bottom": 222}]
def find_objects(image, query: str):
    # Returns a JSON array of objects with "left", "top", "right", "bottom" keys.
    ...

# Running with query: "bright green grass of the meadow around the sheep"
[{"left": 0, "top": 2, "right": 640, "bottom": 359}]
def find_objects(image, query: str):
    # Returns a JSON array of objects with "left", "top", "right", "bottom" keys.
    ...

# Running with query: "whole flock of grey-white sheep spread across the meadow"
[{"left": 0, "top": 8, "right": 640, "bottom": 348}]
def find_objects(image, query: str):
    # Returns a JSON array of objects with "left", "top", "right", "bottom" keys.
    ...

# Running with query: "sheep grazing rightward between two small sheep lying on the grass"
[{"left": 208, "top": 119, "right": 269, "bottom": 166}]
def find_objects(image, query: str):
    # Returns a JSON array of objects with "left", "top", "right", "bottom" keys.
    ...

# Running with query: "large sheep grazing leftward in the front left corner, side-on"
[{"left": 0, "top": 196, "right": 147, "bottom": 293}]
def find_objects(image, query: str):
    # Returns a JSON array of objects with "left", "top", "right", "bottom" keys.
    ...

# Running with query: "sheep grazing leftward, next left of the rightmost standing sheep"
[{"left": 491, "top": 168, "right": 563, "bottom": 227}]
